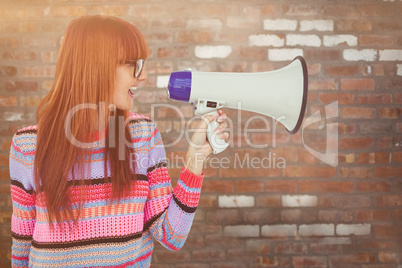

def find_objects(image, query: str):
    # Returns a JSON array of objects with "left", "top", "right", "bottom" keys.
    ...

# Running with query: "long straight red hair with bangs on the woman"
[{"left": 34, "top": 15, "right": 148, "bottom": 226}]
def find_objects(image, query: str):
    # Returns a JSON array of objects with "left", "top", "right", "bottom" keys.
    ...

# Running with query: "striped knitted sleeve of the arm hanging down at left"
[{"left": 9, "top": 131, "right": 36, "bottom": 267}]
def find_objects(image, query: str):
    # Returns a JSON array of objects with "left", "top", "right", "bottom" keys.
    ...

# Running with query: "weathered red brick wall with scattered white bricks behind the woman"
[{"left": 0, "top": 0, "right": 402, "bottom": 268}]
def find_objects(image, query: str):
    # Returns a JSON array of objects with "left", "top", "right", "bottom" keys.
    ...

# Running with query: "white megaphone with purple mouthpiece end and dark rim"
[{"left": 167, "top": 56, "right": 308, "bottom": 154}]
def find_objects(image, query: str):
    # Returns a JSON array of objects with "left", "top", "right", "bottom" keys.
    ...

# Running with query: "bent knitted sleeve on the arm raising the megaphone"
[{"left": 145, "top": 122, "right": 204, "bottom": 250}]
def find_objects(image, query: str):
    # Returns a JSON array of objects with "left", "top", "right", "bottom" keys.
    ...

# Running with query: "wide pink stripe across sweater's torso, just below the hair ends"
[{"left": 34, "top": 214, "right": 144, "bottom": 242}]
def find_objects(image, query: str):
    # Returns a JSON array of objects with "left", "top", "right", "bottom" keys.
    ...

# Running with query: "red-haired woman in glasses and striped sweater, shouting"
[{"left": 10, "top": 16, "right": 228, "bottom": 267}]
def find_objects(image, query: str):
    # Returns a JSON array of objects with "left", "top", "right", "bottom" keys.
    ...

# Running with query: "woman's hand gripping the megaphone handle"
[{"left": 185, "top": 109, "right": 229, "bottom": 175}]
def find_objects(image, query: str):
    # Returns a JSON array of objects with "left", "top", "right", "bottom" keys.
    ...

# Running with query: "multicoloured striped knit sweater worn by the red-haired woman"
[{"left": 10, "top": 113, "right": 204, "bottom": 267}]
